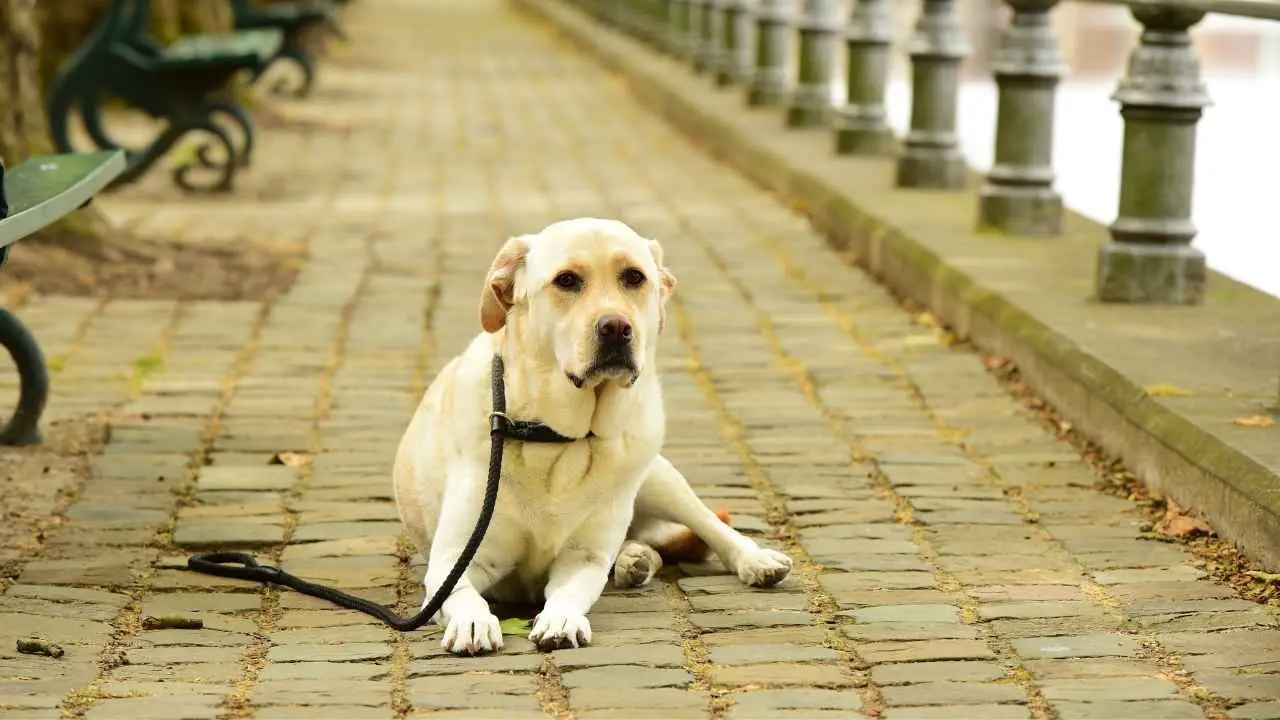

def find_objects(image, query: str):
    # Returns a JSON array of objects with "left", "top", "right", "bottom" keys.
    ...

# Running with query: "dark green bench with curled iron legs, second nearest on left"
[{"left": 49, "top": 0, "right": 284, "bottom": 191}]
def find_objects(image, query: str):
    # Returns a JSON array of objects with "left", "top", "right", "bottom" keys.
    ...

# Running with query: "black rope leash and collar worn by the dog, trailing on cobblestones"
[{"left": 187, "top": 355, "right": 591, "bottom": 632}]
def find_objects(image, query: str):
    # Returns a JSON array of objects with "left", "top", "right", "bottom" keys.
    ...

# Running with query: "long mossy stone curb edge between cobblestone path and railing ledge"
[{"left": 511, "top": 0, "right": 1280, "bottom": 570}]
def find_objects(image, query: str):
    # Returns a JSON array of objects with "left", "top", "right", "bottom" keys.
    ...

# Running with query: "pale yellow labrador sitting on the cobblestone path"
[{"left": 394, "top": 218, "right": 791, "bottom": 653}]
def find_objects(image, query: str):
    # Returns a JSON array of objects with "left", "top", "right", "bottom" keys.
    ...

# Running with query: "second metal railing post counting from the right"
[{"left": 978, "top": 0, "right": 1065, "bottom": 236}]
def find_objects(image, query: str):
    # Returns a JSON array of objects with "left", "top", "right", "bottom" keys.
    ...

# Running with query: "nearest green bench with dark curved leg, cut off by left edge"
[{"left": 0, "top": 150, "right": 125, "bottom": 445}]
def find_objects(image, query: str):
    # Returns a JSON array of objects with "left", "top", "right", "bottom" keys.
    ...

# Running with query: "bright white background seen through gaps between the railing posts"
[{"left": 833, "top": 0, "right": 1280, "bottom": 296}]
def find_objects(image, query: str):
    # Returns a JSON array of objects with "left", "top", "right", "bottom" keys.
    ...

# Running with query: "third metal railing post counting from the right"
[{"left": 897, "top": 0, "right": 969, "bottom": 190}]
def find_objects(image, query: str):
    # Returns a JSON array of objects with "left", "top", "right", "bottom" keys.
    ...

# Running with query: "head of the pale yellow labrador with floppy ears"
[{"left": 480, "top": 218, "right": 676, "bottom": 388}]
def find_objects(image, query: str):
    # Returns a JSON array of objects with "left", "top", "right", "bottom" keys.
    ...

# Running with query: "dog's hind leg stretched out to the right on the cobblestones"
[{"left": 636, "top": 455, "right": 791, "bottom": 588}]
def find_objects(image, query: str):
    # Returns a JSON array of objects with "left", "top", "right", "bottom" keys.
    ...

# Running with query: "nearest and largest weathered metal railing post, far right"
[{"left": 1096, "top": 6, "right": 1210, "bottom": 305}]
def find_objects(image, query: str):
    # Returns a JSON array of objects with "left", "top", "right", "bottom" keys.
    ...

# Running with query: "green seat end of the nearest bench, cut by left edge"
[{"left": 0, "top": 150, "right": 125, "bottom": 247}]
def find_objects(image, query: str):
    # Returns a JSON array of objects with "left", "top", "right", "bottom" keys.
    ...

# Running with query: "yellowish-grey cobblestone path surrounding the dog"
[{"left": 0, "top": 0, "right": 1280, "bottom": 720}]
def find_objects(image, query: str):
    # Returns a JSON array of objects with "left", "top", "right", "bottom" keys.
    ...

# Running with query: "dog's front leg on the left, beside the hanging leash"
[{"left": 422, "top": 468, "right": 518, "bottom": 655}]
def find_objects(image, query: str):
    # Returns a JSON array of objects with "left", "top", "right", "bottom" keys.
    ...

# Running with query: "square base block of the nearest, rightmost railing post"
[{"left": 1097, "top": 242, "right": 1207, "bottom": 305}]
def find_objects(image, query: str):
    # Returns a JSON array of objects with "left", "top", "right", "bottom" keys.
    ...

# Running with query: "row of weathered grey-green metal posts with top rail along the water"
[{"left": 575, "top": 0, "right": 1280, "bottom": 305}]
